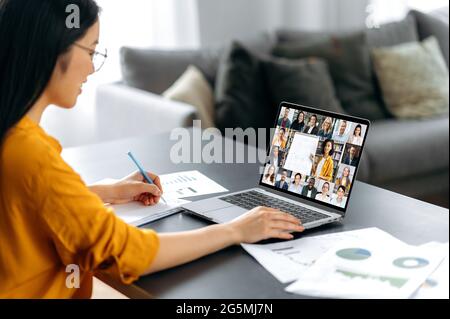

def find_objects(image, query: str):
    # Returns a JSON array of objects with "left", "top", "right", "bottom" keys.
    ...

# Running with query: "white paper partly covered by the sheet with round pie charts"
[{"left": 242, "top": 227, "right": 403, "bottom": 283}]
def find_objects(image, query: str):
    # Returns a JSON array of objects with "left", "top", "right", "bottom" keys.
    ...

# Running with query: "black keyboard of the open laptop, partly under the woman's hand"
[{"left": 220, "top": 191, "right": 329, "bottom": 224}]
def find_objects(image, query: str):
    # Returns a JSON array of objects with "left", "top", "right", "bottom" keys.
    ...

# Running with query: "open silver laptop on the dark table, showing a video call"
[{"left": 183, "top": 102, "right": 370, "bottom": 229}]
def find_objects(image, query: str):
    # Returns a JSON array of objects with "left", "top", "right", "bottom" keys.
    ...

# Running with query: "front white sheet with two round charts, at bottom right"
[{"left": 286, "top": 240, "right": 448, "bottom": 298}]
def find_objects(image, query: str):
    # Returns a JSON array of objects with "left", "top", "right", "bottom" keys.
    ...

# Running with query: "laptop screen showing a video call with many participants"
[{"left": 260, "top": 103, "right": 370, "bottom": 211}]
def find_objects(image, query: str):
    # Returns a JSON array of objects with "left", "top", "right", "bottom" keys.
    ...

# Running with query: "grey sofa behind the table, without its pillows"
[{"left": 97, "top": 12, "right": 449, "bottom": 207}]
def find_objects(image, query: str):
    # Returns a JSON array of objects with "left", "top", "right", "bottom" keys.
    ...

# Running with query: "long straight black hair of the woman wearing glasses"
[{"left": 0, "top": 0, "right": 100, "bottom": 144}]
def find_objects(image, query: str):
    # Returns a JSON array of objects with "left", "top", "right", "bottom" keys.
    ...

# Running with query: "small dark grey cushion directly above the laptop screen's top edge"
[{"left": 263, "top": 58, "right": 345, "bottom": 113}]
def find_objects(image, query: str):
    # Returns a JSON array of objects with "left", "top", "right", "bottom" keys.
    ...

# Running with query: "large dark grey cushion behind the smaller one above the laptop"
[{"left": 273, "top": 32, "right": 386, "bottom": 120}]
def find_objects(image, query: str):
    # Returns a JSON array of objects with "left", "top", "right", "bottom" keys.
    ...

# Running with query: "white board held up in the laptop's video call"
[{"left": 283, "top": 132, "right": 319, "bottom": 175}]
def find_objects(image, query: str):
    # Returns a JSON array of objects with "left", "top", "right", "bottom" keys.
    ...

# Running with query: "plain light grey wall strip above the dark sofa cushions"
[{"left": 197, "top": 0, "right": 369, "bottom": 46}]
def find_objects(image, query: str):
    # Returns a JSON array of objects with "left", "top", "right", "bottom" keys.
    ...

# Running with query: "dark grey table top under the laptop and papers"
[{"left": 63, "top": 129, "right": 449, "bottom": 299}]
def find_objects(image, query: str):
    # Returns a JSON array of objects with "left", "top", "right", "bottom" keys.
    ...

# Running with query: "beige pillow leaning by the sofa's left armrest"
[{"left": 162, "top": 65, "right": 214, "bottom": 128}]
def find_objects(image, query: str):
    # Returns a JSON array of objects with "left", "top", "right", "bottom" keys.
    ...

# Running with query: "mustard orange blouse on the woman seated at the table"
[{"left": 0, "top": 117, "right": 159, "bottom": 298}]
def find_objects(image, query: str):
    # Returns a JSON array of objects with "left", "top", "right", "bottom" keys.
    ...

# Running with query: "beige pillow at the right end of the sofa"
[{"left": 372, "top": 36, "right": 449, "bottom": 118}]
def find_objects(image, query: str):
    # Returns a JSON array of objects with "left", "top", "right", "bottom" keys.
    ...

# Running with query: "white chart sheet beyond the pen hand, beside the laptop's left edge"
[{"left": 159, "top": 171, "right": 228, "bottom": 199}]
